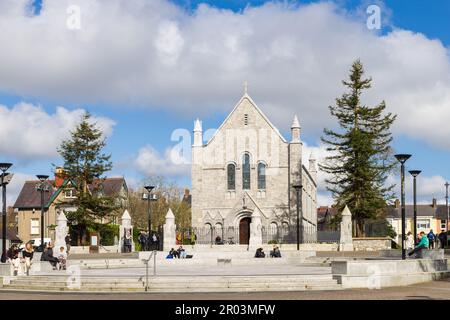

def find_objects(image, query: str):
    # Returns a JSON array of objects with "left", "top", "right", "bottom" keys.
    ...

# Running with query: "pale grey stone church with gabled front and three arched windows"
[{"left": 192, "top": 93, "right": 317, "bottom": 244}]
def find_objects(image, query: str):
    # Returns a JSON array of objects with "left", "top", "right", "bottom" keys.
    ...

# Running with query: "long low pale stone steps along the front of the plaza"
[{"left": 3, "top": 275, "right": 341, "bottom": 292}]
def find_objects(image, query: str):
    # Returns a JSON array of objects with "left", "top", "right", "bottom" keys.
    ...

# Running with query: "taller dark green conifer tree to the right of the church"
[{"left": 320, "top": 60, "right": 396, "bottom": 236}]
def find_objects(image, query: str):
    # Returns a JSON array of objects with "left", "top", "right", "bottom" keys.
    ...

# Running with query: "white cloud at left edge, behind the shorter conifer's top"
[{"left": 0, "top": 102, "right": 114, "bottom": 161}]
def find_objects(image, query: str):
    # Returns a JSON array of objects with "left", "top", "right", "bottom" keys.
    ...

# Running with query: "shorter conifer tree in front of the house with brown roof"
[{"left": 58, "top": 113, "right": 117, "bottom": 242}]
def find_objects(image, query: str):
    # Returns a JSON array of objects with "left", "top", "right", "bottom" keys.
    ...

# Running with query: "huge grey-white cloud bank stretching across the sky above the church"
[{"left": 0, "top": 0, "right": 450, "bottom": 148}]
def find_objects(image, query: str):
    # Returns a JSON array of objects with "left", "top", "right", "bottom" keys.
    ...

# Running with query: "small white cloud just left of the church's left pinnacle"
[{"left": 135, "top": 146, "right": 191, "bottom": 177}]
